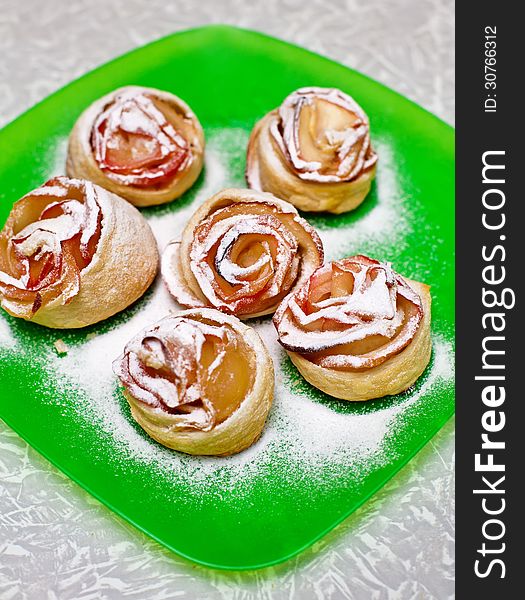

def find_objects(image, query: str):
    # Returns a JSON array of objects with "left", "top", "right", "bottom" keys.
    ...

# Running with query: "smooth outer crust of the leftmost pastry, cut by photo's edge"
[{"left": 1, "top": 178, "right": 159, "bottom": 329}]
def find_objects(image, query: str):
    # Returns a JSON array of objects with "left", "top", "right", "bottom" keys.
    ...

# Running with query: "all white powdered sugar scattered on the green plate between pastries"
[{"left": 0, "top": 129, "right": 453, "bottom": 504}]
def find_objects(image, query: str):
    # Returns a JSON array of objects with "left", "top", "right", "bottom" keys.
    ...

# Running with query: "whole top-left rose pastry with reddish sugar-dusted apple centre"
[{"left": 66, "top": 86, "right": 204, "bottom": 206}]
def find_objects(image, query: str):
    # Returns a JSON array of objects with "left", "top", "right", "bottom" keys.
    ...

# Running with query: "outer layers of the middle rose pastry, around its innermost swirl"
[{"left": 162, "top": 189, "right": 323, "bottom": 319}]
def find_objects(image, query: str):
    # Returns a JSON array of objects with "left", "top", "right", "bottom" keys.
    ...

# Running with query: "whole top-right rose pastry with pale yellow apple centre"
[{"left": 246, "top": 87, "right": 377, "bottom": 213}]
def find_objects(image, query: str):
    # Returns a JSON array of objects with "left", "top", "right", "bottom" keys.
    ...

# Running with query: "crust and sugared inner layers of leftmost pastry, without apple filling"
[{"left": 1, "top": 177, "right": 159, "bottom": 329}]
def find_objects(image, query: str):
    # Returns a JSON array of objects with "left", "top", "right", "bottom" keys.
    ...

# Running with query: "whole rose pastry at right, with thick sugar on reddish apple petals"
[{"left": 274, "top": 256, "right": 431, "bottom": 400}]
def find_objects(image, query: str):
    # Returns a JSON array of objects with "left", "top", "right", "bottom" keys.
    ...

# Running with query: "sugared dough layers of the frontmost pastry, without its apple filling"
[{"left": 113, "top": 308, "right": 274, "bottom": 456}]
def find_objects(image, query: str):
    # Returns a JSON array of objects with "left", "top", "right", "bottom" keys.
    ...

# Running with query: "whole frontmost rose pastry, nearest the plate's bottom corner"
[{"left": 113, "top": 308, "right": 274, "bottom": 455}]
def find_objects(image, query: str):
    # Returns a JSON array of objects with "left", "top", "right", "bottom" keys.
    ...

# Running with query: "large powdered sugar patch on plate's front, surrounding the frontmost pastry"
[{"left": 27, "top": 298, "right": 453, "bottom": 496}]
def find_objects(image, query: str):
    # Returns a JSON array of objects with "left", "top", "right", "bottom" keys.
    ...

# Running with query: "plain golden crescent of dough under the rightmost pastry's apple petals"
[{"left": 287, "top": 279, "right": 432, "bottom": 401}]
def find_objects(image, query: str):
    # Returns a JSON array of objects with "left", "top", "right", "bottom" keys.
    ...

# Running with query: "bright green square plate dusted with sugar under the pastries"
[{"left": 0, "top": 26, "right": 454, "bottom": 569}]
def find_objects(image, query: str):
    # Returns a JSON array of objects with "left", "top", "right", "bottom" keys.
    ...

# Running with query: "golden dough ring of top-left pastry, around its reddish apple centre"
[{"left": 66, "top": 86, "right": 204, "bottom": 206}]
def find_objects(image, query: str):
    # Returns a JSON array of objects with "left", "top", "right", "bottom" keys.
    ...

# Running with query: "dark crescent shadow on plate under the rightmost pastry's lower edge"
[{"left": 281, "top": 350, "right": 434, "bottom": 415}]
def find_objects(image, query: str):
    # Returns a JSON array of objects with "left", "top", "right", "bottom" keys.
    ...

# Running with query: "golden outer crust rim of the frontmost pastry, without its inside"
[{"left": 114, "top": 308, "right": 274, "bottom": 456}]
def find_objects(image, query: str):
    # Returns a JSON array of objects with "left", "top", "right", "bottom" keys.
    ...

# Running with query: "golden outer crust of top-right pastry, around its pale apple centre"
[{"left": 246, "top": 88, "right": 377, "bottom": 214}]
